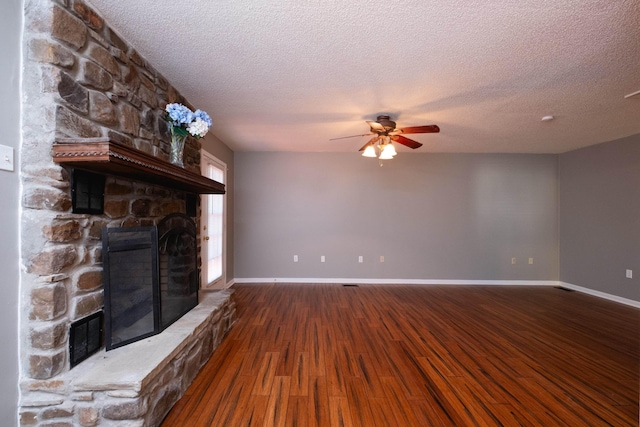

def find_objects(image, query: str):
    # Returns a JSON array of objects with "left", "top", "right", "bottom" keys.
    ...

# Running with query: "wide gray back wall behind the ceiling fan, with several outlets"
[{"left": 234, "top": 152, "right": 559, "bottom": 280}]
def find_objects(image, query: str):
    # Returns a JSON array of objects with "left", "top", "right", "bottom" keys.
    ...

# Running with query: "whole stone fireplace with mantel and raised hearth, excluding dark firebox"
[{"left": 19, "top": 0, "right": 235, "bottom": 427}]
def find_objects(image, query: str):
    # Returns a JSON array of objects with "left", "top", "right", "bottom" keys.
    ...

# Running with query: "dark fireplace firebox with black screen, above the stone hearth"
[{"left": 102, "top": 214, "right": 199, "bottom": 350}]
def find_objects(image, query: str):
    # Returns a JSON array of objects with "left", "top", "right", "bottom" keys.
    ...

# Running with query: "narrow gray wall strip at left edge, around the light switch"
[{"left": 0, "top": 0, "right": 22, "bottom": 426}]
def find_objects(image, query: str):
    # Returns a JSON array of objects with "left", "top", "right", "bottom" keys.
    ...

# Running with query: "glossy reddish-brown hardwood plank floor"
[{"left": 163, "top": 284, "right": 640, "bottom": 427}]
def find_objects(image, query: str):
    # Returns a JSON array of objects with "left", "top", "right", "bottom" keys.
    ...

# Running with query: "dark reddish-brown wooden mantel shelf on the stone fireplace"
[{"left": 53, "top": 137, "right": 225, "bottom": 194}]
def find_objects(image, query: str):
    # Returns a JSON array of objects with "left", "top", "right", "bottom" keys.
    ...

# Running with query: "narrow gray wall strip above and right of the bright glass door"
[{"left": 202, "top": 135, "right": 235, "bottom": 282}]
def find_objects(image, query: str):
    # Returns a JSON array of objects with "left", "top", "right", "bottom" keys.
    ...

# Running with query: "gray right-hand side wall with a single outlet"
[{"left": 559, "top": 134, "right": 640, "bottom": 301}]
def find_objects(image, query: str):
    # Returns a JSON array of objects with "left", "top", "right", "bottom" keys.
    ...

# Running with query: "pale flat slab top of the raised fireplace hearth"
[{"left": 68, "top": 290, "right": 233, "bottom": 397}]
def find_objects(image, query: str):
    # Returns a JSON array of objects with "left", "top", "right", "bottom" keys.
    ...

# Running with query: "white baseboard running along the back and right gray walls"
[{"left": 227, "top": 277, "right": 640, "bottom": 308}]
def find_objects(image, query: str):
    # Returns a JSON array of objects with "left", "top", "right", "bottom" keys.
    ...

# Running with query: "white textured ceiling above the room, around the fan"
[{"left": 87, "top": 0, "right": 640, "bottom": 153}]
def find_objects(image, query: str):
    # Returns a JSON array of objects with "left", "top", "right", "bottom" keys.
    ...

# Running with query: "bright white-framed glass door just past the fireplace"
[{"left": 201, "top": 150, "right": 227, "bottom": 288}]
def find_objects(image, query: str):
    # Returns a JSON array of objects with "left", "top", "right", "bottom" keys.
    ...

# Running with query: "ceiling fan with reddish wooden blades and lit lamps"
[{"left": 331, "top": 116, "right": 440, "bottom": 160}]
